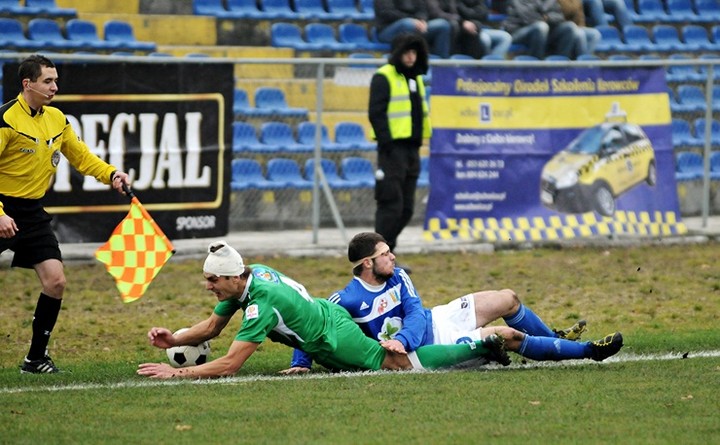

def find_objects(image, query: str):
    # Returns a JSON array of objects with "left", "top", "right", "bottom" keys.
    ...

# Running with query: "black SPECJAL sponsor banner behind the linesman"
[{"left": 3, "top": 62, "right": 234, "bottom": 242}]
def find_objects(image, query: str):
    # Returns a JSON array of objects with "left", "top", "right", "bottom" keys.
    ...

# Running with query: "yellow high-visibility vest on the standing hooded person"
[{"left": 372, "top": 64, "right": 432, "bottom": 139}]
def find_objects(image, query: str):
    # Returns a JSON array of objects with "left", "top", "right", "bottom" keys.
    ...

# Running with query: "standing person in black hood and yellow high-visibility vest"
[{"left": 368, "top": 34, "right": 431, "bottom": 270}]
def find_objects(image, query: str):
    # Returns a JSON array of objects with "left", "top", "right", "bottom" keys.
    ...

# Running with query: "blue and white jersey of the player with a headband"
[{"left": 291, "top": 267, "right": 433, "bottom": 368}]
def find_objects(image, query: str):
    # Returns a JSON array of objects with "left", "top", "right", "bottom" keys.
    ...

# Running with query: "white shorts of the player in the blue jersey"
[{"left": 431, "top": 294, "right": 482, "bottom": 345}]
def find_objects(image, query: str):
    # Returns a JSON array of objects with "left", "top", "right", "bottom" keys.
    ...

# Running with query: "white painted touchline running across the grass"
[{"left": 0, "top": 350, "right": 720, "bottom": 394}]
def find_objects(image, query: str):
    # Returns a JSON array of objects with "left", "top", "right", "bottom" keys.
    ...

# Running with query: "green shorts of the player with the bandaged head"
[{"left": 309, "top": 300, "right": 385, "bottom": 371}]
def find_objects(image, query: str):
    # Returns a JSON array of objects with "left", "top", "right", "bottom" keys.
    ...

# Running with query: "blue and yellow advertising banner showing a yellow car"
[{"left": 425, "top": 67, "right": 686, "bottom": 242}]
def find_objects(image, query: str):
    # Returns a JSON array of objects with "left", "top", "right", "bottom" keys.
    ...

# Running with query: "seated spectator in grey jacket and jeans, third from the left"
[{"left": 504, "top": 0, "right": 576, "bottom": 59}]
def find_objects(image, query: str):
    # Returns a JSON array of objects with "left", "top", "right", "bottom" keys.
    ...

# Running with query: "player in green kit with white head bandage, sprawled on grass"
[{"left": 137, "top": 241, "right": 510, "bottom": 379}]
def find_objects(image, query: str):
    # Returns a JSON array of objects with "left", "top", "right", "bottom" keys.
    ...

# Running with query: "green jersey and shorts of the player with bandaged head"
[{"left": 214, "top": 264, "right": 385, "bottom": 370}]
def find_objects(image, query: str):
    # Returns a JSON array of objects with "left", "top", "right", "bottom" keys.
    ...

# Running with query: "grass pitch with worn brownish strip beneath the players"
[{"left": 0, "top": 243, "right": 720, "bottom": 444}]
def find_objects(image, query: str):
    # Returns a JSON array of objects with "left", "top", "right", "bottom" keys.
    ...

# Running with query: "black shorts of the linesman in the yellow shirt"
[{"left": 0, "top": 195, "right": 62, "bottom": 269}]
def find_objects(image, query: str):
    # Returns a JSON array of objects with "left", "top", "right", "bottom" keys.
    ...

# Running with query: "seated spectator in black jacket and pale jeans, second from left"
[{"left": 428, "top": 0, "right": 512, "bottom": 59}]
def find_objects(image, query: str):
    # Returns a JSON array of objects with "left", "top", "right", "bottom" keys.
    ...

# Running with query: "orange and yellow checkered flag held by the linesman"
[{"left": 95, "top": 194, "right": 175, "bottom": 303}]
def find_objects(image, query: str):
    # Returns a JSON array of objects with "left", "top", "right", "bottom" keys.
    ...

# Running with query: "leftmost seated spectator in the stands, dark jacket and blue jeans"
[{"left": 373, "top": 0, "right": 452, "bottom": 59}]
